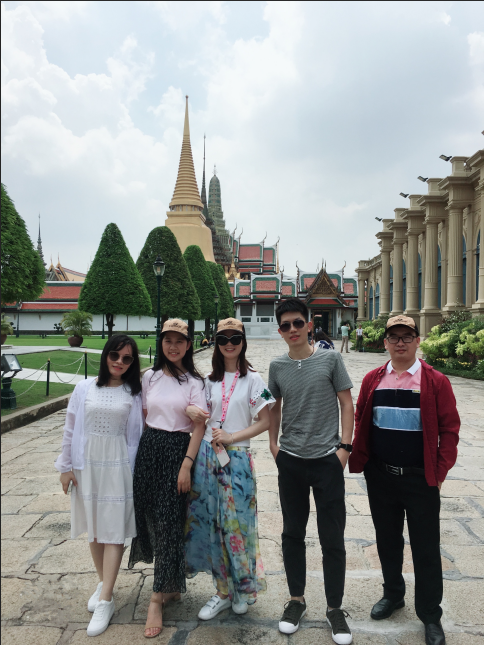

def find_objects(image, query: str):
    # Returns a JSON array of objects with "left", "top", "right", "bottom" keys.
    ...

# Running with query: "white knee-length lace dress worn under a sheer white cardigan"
[{"left": 71, "top": 381, "right": 136, "bottom": 544}]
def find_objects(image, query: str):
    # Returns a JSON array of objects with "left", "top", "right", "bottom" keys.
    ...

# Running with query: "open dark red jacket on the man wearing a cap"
[{"left": 349, "top": 360, "right": 460, "bottom": 486}]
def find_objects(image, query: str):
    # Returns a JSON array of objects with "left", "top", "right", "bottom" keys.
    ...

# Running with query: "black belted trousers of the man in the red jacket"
[{"left": 365, "top": 460, "right": 443, "bottom": 625}]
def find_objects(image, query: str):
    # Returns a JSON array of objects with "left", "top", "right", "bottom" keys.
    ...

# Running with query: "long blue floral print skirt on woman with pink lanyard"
[{"left": 185, "top": 440, "right": 267, "bottom": 605}]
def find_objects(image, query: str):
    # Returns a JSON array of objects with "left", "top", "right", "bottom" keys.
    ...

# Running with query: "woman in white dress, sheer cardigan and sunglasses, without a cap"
[{"left": 55, "top": 335, "right": 144, "bottom": 636}]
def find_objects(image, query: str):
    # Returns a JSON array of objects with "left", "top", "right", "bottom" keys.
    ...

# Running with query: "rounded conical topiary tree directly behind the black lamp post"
[{"left": 136, "top": 226, "right": 200, "bottom": 320}]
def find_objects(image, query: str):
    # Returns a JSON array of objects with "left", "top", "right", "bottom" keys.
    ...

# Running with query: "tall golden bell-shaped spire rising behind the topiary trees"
[{"left": 165, "top": 96, "right": 215, "bottom": 262}]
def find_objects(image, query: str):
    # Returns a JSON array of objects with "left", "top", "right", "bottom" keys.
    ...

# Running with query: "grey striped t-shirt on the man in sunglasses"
[{"left": 269, "top": 350, "right": 353, "bottom": 459}]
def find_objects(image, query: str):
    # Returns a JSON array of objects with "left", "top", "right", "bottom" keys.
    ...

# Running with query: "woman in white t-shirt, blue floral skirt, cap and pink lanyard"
[{"left": 185, "top": 318, "right": 275, "bottom": 620}]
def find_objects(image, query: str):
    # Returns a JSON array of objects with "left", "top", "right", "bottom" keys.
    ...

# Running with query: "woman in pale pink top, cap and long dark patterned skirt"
[{"left": 128, "top": 318, "right": 207, "bottom": 638}]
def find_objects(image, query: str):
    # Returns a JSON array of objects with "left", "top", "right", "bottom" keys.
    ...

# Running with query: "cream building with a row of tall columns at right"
[{"left": 356, "top": 150, "right": 484, "bottom": 336}]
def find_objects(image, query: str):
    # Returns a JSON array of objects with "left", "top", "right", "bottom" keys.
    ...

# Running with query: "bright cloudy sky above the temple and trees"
[{"left": 2, "top": 0, "right": 484, "bottom": 275}]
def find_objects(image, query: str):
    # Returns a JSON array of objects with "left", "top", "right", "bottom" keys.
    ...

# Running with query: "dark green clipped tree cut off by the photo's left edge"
[{"left": 1, "top": 184, "right": 45, "bottom": 303}]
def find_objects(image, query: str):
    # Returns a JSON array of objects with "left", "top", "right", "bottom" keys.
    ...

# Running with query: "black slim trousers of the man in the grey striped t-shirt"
[{"left": 276, "top": 450, "right": 346, "bottom": 608}]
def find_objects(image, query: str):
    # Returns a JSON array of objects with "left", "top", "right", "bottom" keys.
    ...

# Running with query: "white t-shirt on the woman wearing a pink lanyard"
[{"left": 203, "top": 369, "right": 276, "bottom": 447}]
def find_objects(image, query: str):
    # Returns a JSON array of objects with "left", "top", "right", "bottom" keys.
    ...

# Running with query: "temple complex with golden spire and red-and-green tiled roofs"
[{"left": 165, "top": 100, "right": 358, "bottom": 338}]
